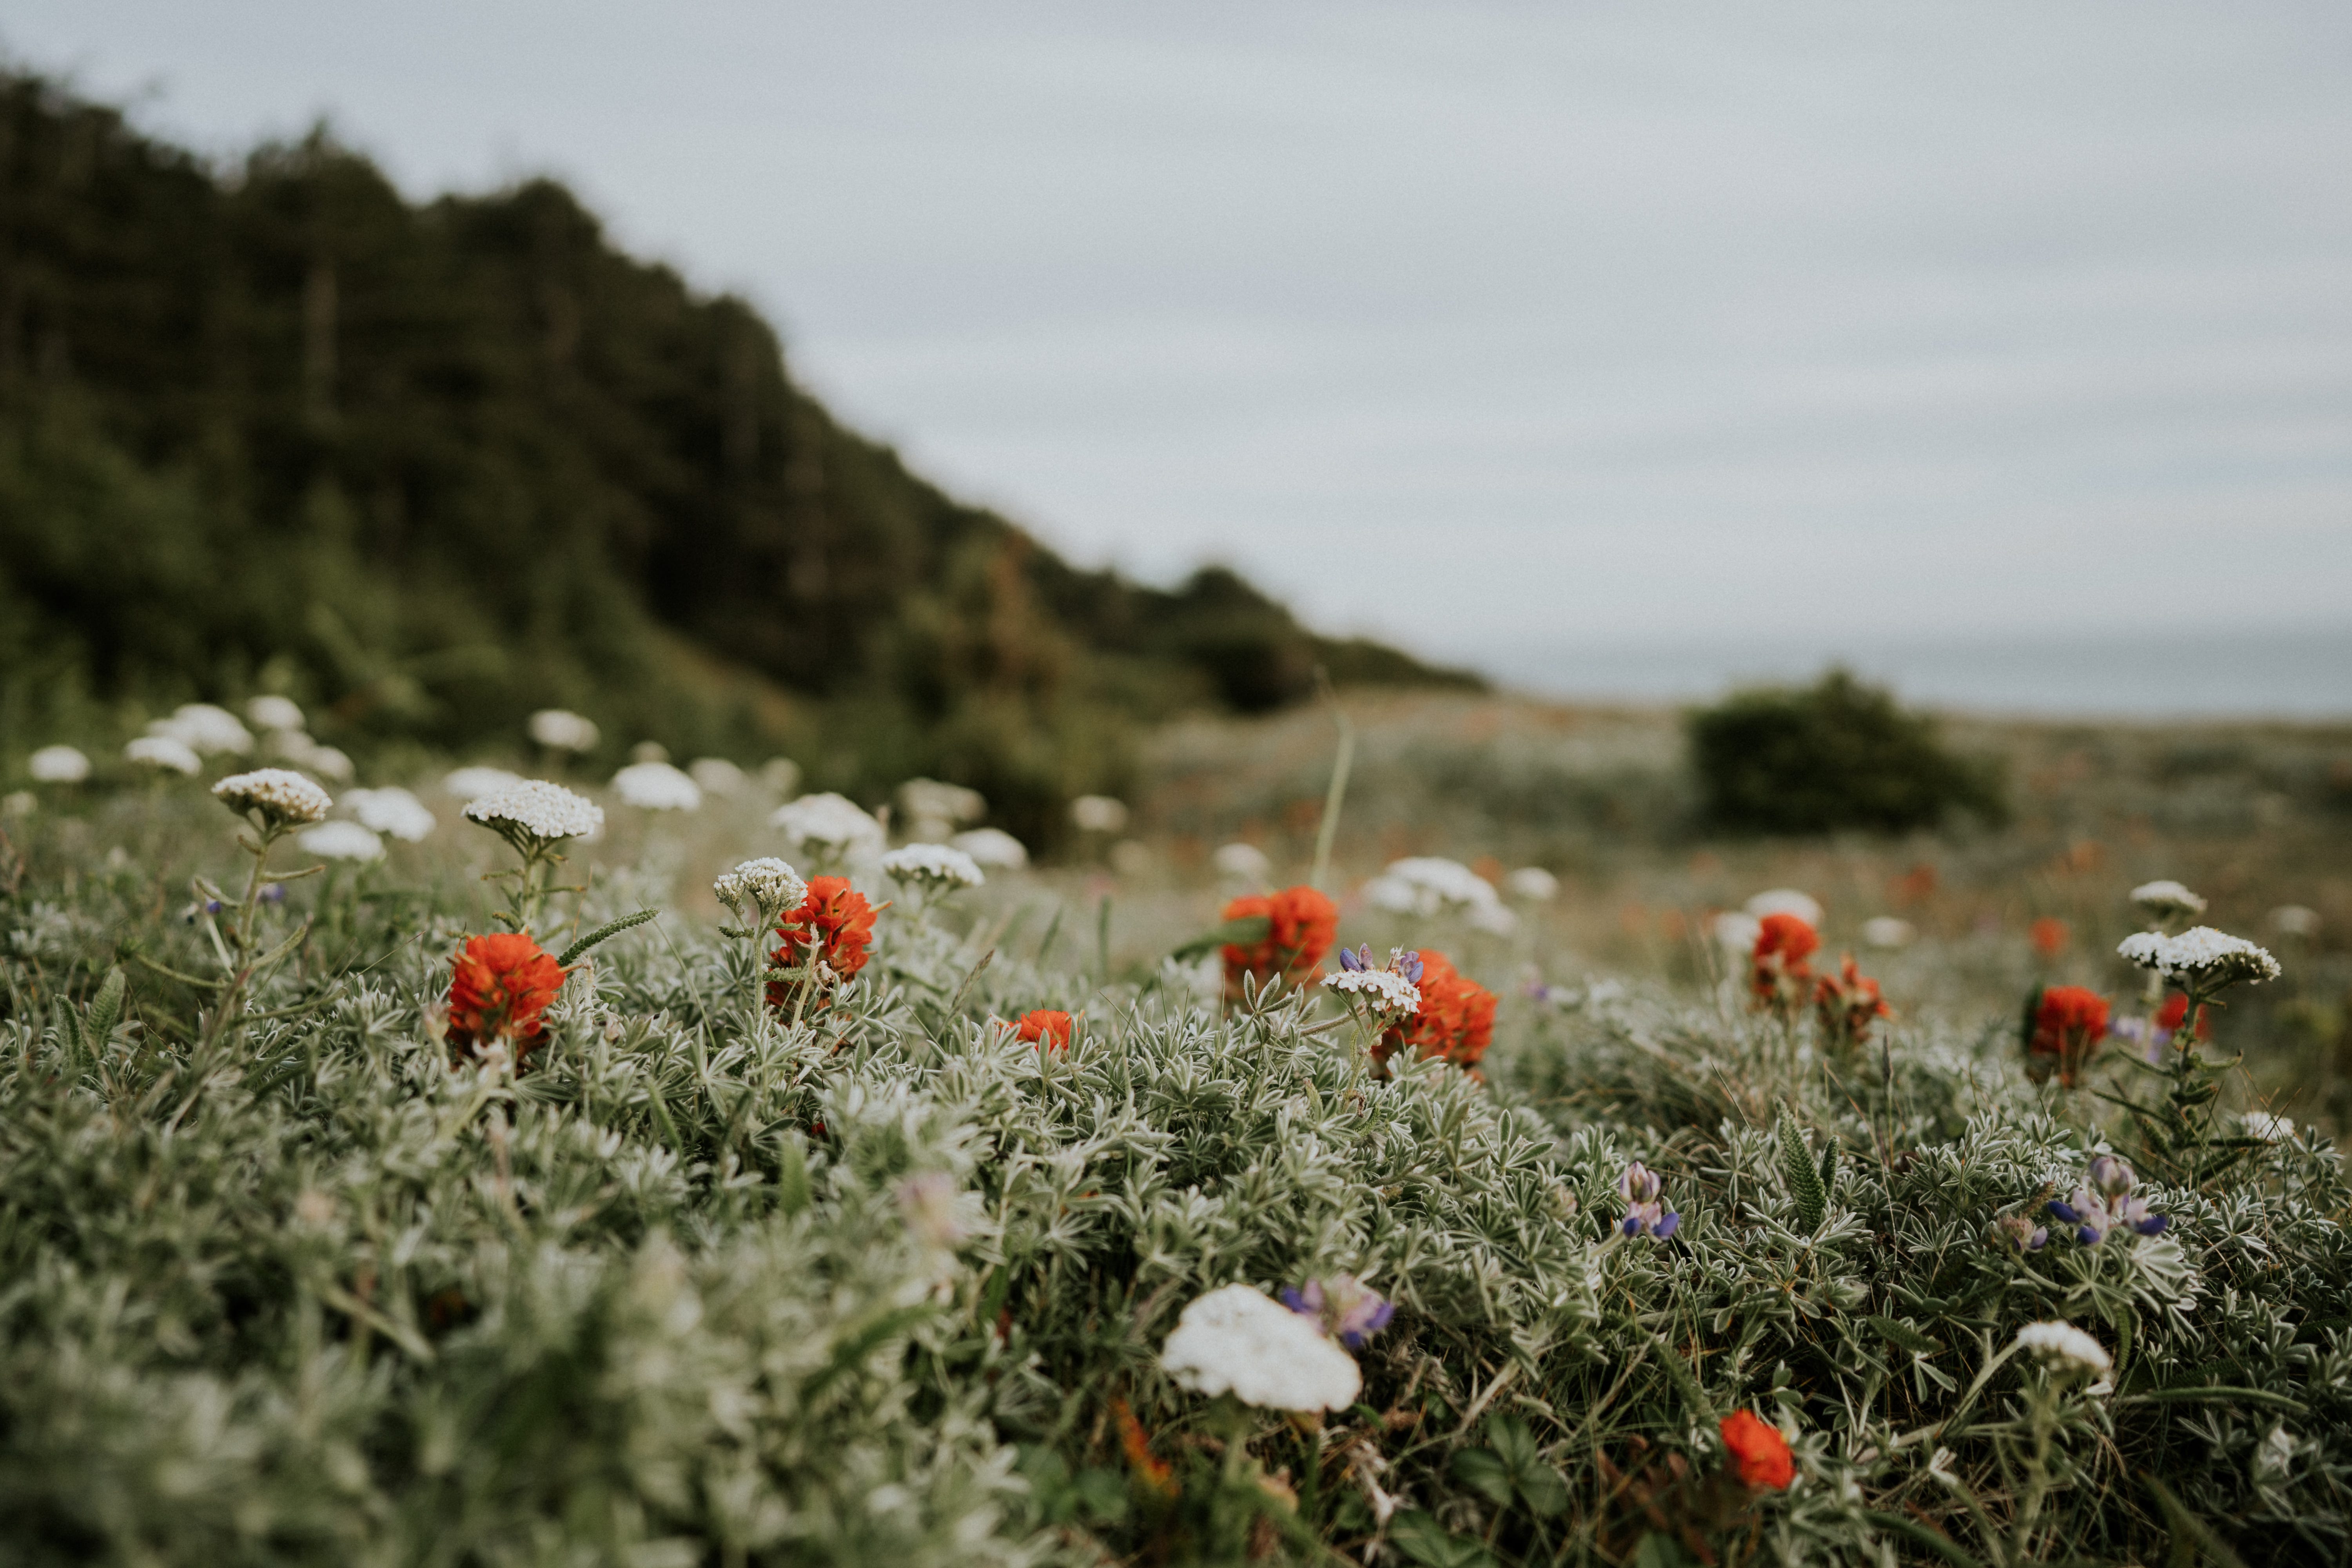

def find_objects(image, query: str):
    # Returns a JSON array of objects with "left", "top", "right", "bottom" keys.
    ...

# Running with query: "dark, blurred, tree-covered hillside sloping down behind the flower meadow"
[{"left": 0, "top": 75, "right": 1477, "bottom": 832}]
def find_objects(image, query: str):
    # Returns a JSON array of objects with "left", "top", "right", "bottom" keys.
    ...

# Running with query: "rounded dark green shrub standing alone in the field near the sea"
[{"left": 1689, "top": 670, "right": 2009, "bottom": 832}]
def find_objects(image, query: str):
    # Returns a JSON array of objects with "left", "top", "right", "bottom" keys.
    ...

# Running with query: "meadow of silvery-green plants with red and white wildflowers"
[{"left": 0, "top": 698, "right": 2352, "bottom": 1568}]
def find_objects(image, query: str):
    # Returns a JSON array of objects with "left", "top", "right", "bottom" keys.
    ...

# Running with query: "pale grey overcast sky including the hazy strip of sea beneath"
[{"left": 0, "top": 0, "right": 2352, "bottom": 712}]
